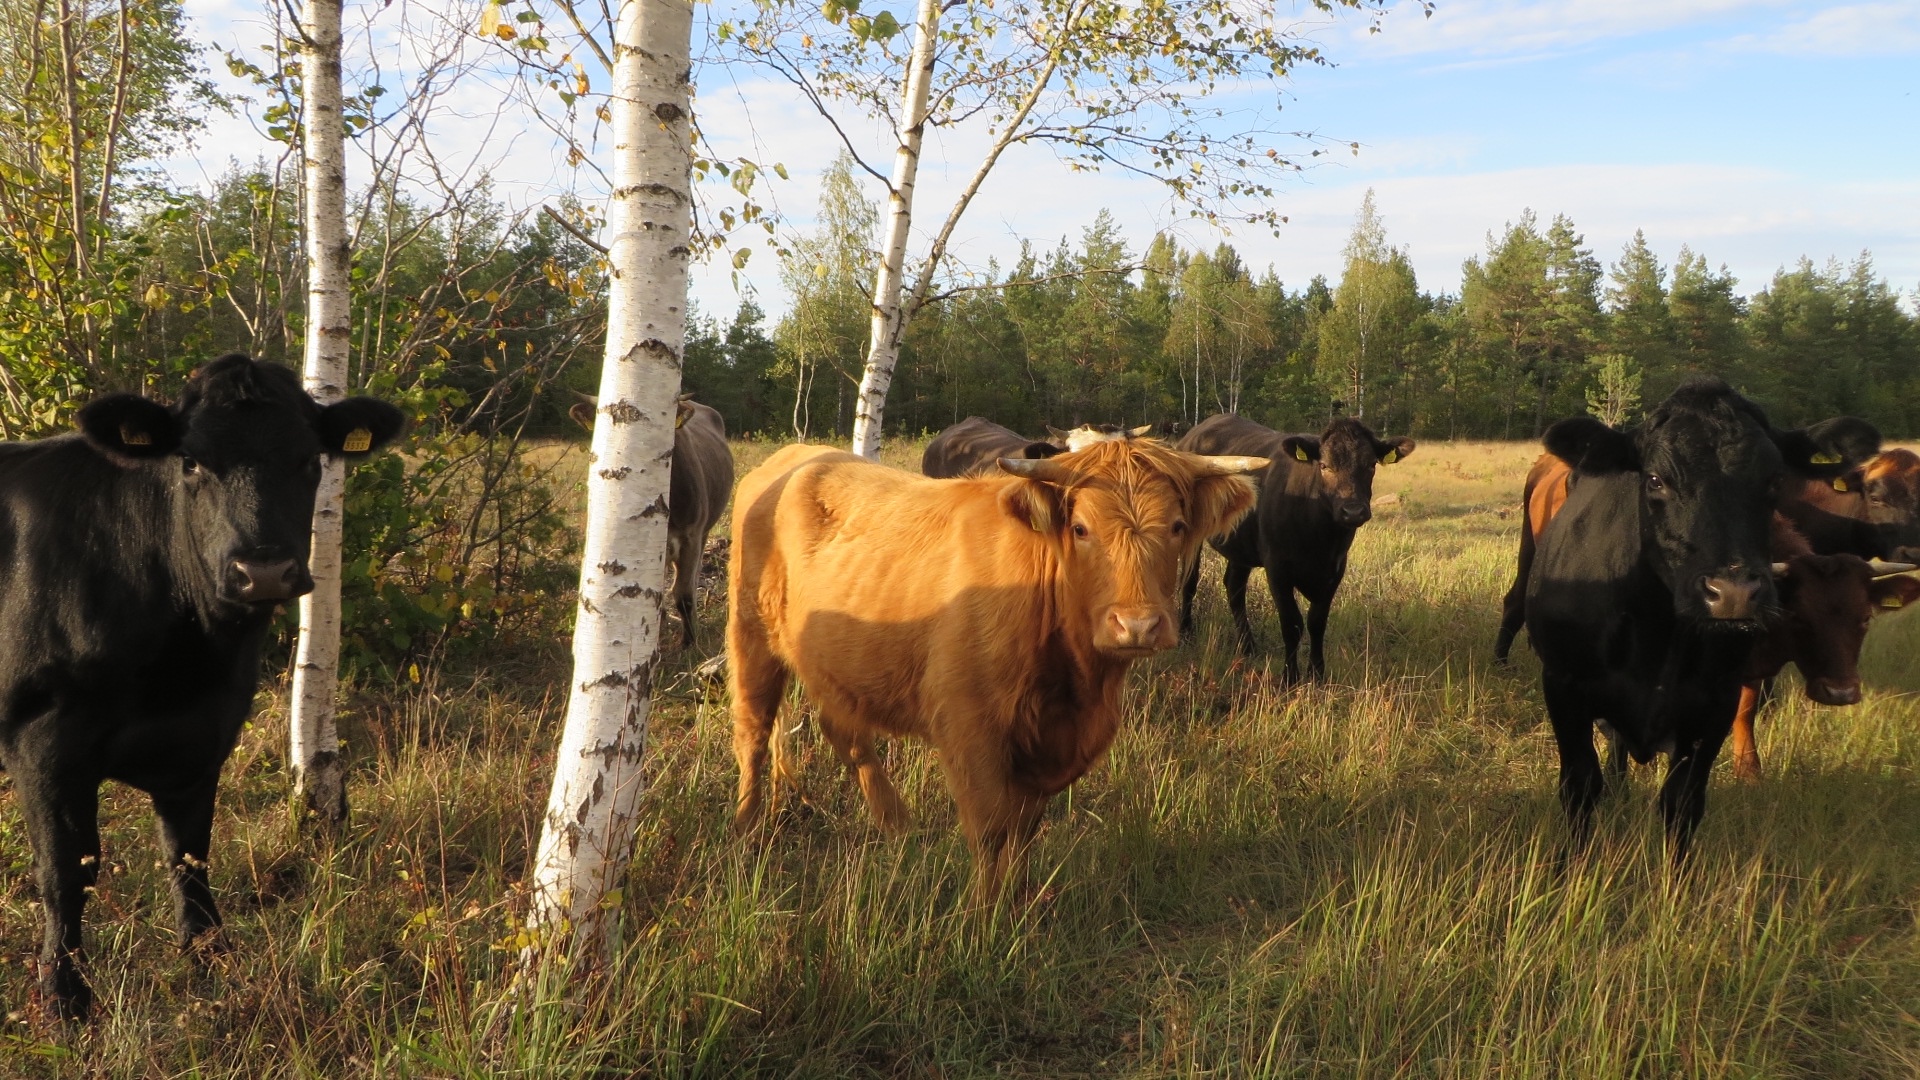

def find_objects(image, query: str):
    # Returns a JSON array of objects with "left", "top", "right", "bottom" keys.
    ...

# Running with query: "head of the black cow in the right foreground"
[{"left": 1542, "top": 379, "right": 1880, "bottom": 628}]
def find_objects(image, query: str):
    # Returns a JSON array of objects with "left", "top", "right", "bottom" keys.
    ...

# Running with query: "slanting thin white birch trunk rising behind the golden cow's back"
[{"left": 852, "top": 0, "right": 941, "bottom": 459}]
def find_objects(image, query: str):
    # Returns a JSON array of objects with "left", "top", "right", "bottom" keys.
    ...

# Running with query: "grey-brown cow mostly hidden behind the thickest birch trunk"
[{"left": 566, "top": 394, "right": 733, "bottom": 650}]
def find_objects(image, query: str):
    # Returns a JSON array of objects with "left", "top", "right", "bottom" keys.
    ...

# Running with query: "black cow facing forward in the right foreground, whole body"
[{"left": 1526, "top": 379, "right": 1880, "bottom": 859}]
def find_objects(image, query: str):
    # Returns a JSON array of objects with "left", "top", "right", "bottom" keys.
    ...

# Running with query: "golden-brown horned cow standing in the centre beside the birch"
[{"left": 728, "top": 440, "right": 1265, "bottom": 894}]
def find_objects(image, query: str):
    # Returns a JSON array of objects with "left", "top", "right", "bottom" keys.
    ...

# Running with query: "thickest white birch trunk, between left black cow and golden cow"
[{"left": 530, "top": 0, "right": 693, "bottom": 947}]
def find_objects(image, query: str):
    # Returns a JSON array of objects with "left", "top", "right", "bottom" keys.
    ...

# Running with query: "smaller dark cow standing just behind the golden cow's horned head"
[{"left": 1179, "top": 413, "right": 1413, "bottom": 682}]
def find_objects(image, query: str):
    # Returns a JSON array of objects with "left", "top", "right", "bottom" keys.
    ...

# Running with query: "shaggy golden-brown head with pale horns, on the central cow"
[{"left": 1000, "top": 438, "right": 1267, "bottom": 659}]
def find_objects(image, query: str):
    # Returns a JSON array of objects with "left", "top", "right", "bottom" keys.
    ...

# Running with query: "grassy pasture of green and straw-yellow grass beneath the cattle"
[{"left": 0, "top": 444, "right": 1920, "bottom": 1078}]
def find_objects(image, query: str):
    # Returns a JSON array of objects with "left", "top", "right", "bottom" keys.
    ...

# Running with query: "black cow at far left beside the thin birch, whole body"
[{"left": 0, "top": 356, "right": 401, "bottom": 1019}]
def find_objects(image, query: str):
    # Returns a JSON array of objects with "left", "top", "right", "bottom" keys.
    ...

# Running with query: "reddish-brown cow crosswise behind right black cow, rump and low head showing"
[{"left": 1494, "top": 454, "right": 1920, "bottom": 780}]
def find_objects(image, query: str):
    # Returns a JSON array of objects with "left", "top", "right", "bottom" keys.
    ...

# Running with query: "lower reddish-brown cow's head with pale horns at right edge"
[{"left": 1768, "top": 555, "right": 1920, "bottom": 705}]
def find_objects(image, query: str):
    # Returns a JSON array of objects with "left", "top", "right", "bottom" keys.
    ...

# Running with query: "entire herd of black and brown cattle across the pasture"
[{"left": 0, "top": 356, "right": 1920, "bottom": 1019}]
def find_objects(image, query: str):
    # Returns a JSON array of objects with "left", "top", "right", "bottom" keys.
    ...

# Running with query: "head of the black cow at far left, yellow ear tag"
[{"left": 79, "top": 356, "right": 403, "bottom": 607}]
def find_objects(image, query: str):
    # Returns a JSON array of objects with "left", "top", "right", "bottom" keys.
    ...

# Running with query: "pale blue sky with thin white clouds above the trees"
[{"left": 173, "top": 0, "right": 1920, "bottom": 313}]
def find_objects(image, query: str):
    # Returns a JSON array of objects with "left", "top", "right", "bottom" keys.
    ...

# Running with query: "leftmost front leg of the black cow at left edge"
[{"left": 8, "top": 761, "right": 100, "bottom": 1020}]
